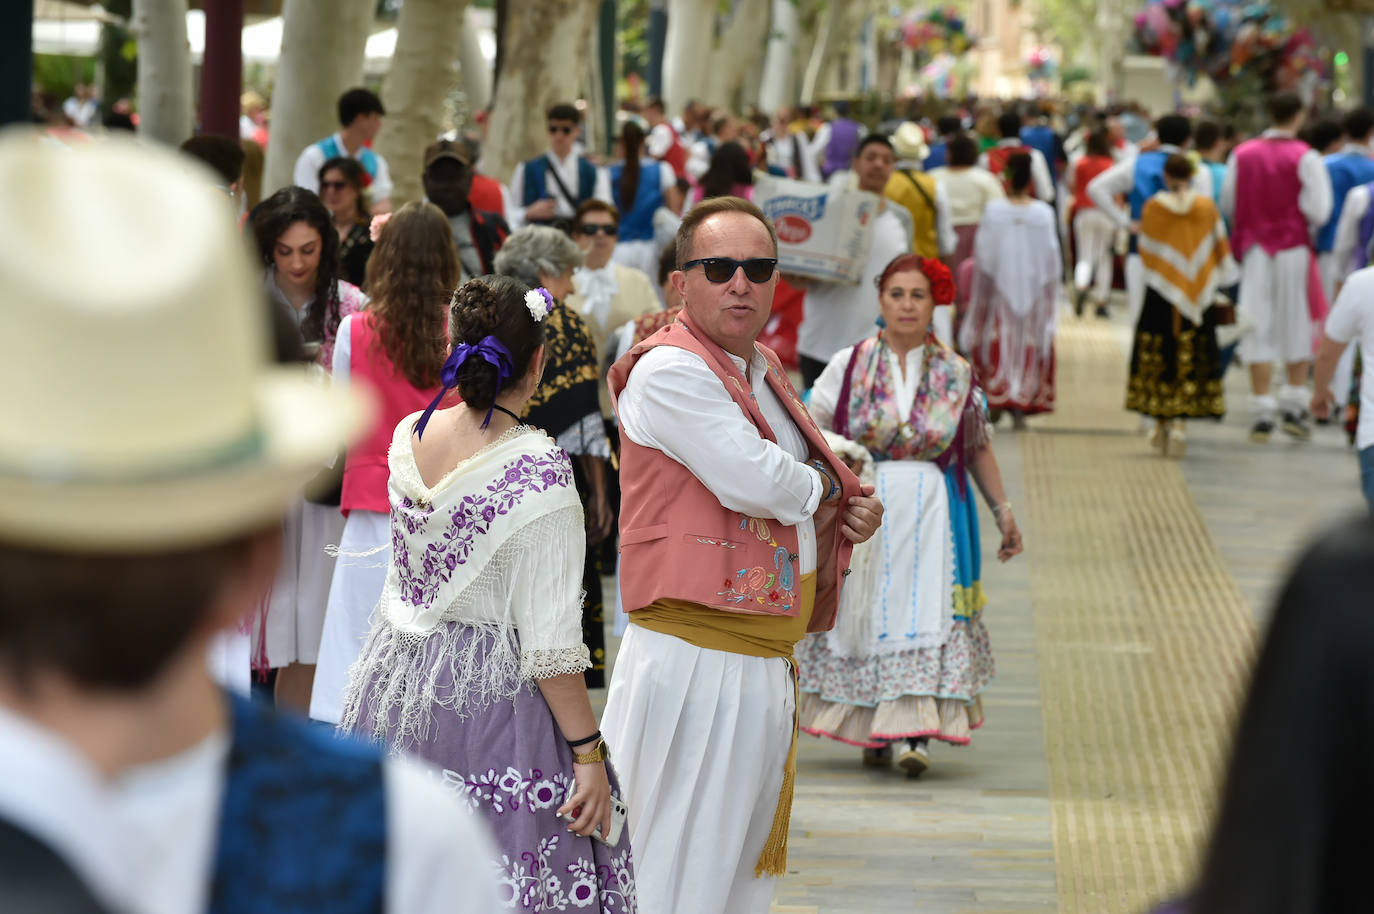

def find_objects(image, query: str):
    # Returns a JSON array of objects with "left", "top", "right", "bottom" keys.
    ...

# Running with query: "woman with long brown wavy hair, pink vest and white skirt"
[{"left": 311, "top": 202, "right": 459, "bottom": 723}]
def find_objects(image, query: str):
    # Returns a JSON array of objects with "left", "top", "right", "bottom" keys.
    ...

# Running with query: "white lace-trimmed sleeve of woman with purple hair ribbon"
[{"left": 505, "top": 504, "right": 592, "bottom": 679}]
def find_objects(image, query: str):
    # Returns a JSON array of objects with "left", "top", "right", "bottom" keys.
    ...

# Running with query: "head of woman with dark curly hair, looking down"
[{"left": 251, "top": 187, "right": 367, "bottom": 368}]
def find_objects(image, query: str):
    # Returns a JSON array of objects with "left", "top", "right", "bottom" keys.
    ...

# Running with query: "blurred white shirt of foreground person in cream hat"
[{"left": 0, "top": 708, "right": 497, "bottom": 914}]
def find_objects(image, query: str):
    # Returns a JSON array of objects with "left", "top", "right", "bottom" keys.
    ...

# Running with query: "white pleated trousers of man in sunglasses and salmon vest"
[{"left": 602, "top": 621, "right": 796, "bottom": 914}]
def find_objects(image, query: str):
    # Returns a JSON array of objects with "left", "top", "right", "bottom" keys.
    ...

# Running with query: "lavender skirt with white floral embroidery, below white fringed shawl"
[{"left": 354, "top": 623, "right": 638, "bottom": 914}]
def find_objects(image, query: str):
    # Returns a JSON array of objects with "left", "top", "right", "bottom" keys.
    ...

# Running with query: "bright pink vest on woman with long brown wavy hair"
[{"left": 339, "top": 311, "right": 438, "bottom": 514}]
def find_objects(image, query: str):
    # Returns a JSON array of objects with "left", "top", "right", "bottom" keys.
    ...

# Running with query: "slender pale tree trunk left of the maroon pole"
[{"left": 133, "top": 0, "right": 191, "bottom": 146}]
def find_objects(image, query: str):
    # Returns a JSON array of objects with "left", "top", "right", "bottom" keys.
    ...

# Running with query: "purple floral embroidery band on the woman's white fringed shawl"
[{"left": 392, "top": 451, "right": 573, "bottom": 606}]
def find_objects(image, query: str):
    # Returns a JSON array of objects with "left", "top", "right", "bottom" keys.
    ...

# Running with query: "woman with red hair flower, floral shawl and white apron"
[{"left": 797, "top": 254, "right": 1021, "bottom": 775}]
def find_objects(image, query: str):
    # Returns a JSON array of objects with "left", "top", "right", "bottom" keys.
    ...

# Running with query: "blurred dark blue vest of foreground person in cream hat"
[{"left": 207, "top": 697, "right": 386, "bottom": 914}]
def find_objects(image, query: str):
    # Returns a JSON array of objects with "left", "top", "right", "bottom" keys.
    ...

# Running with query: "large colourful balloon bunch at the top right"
[{"left": 1134, "top": 0, "right": 1327, "bottom": 92}]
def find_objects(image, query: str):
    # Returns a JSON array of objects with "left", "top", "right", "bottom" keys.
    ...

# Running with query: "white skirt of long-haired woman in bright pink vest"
[{"left": 311, "top": 511, "right": 392, "bottom": 723}]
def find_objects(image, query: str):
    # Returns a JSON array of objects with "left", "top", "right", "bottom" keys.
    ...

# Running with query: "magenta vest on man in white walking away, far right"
[{"left": 1231, "top": 137, "right": 1311, "bottom": 260}]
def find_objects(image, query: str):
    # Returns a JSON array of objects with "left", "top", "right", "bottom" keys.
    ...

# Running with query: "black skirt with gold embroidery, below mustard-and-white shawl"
[{"left": 1125, "top": 289, "right": 1226, "bottom": 419}]
